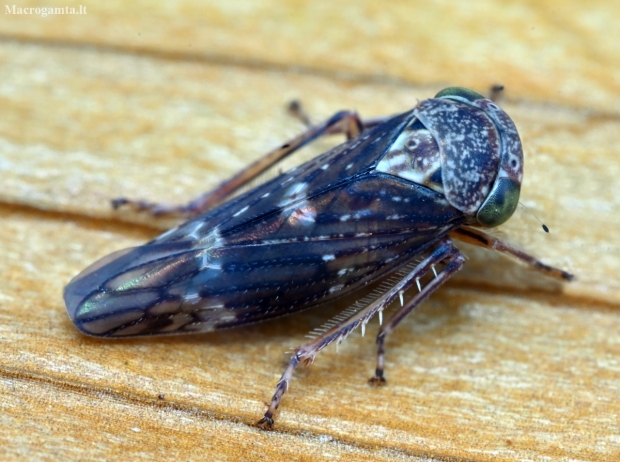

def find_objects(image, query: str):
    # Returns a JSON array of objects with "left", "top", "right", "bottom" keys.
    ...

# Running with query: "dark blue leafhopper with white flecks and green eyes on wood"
[{"left": 64, "top": 87, "right": 573, "bottom": 427}]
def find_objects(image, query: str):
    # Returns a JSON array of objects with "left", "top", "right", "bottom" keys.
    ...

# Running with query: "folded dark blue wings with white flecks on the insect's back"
[{"left": 65, "top": 115, "right": 465, "bottom": 336}]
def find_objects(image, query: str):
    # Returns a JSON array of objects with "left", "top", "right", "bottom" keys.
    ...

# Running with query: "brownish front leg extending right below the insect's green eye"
[{"left": 450, "top": 227, "right": 575, "bottom": 281}]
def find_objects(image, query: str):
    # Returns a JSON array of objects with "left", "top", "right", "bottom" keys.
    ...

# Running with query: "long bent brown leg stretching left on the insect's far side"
[{"left": 112, "top": 111, "right": 365, "bottom": 217}]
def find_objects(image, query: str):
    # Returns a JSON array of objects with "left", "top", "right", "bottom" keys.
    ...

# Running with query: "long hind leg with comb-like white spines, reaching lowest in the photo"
[{"left": 257, "top": 239, "right": 464, "bottom": 428}]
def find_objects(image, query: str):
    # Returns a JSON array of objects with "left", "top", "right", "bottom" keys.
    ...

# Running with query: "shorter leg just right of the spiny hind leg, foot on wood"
[{"left": 370, "top": 241, "right": 465, "bottom": 384}]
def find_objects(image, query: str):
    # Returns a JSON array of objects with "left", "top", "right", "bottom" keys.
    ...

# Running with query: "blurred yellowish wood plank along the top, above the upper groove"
[{"left": 0, "top": 0, "right": 620, "bottom": 112}]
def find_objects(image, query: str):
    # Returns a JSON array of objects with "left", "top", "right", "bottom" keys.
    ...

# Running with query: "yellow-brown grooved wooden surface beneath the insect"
[{"left": 0, "top": 0, "right": 620, "bottom": 461}]
